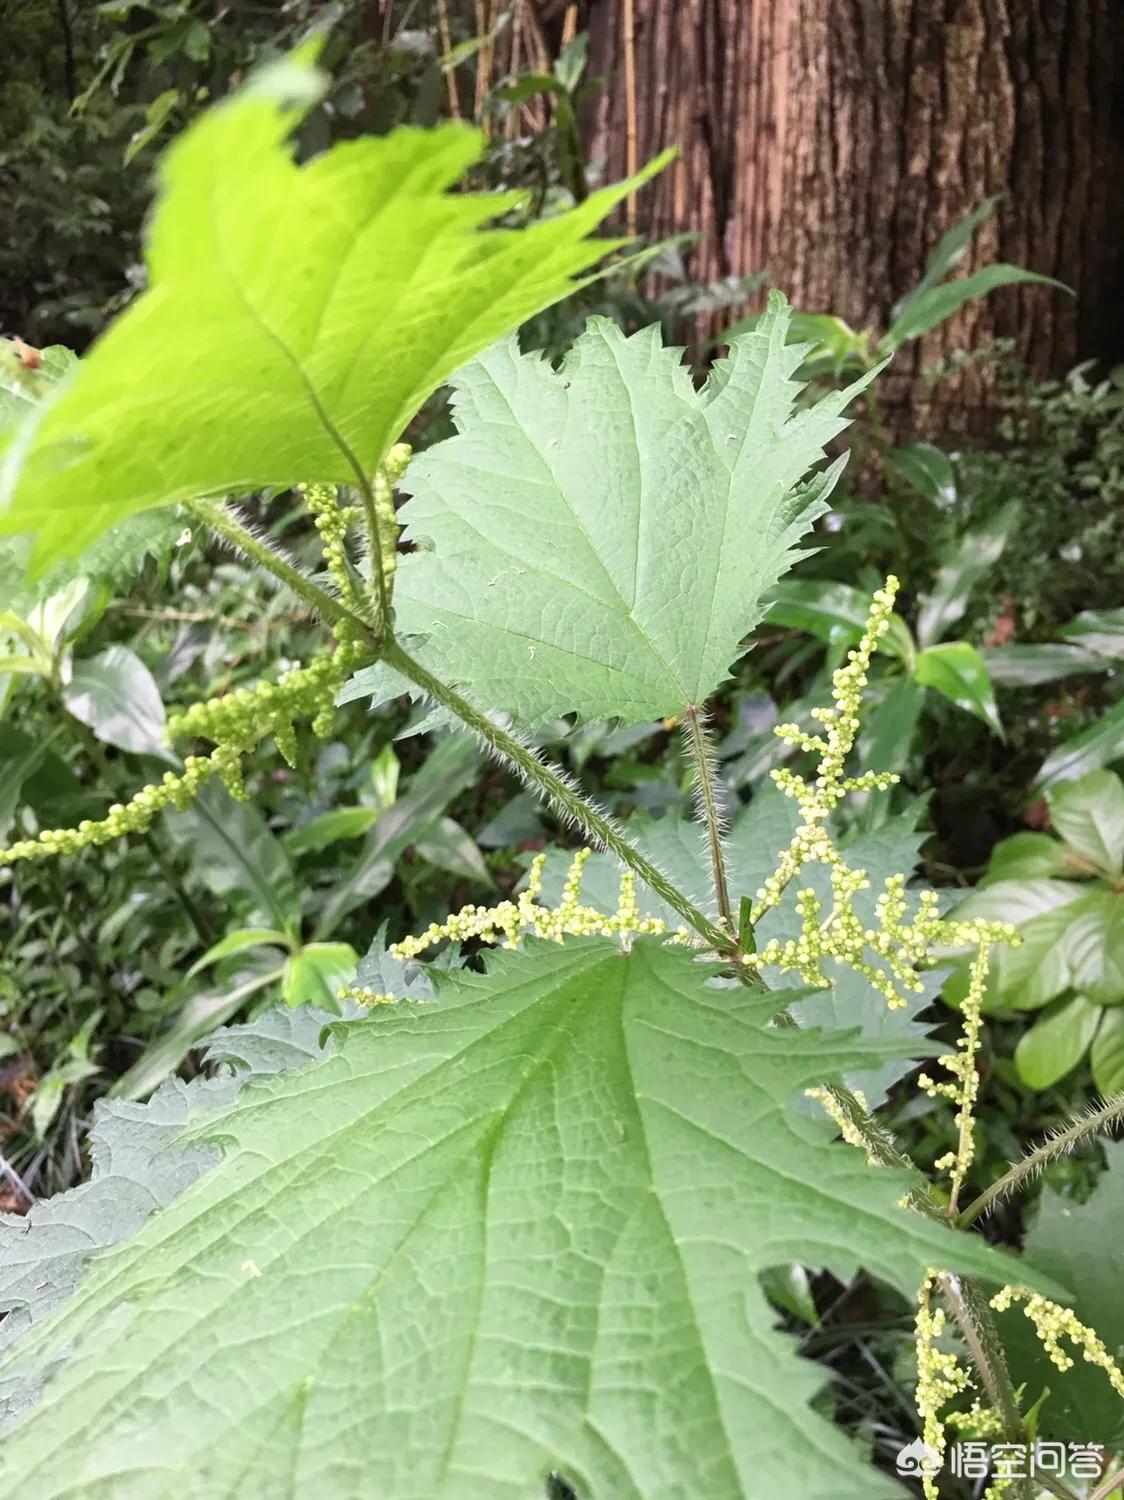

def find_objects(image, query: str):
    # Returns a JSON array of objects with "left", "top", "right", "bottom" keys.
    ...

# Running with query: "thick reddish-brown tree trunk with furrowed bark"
[{"left": 585, "top": 0, "right": 1124, "bottom": 432}]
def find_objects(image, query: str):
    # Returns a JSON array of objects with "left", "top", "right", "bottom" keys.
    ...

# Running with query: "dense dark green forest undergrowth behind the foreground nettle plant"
[{"left": 0, "top": 0, "right": 1124, "bottom": 1494}]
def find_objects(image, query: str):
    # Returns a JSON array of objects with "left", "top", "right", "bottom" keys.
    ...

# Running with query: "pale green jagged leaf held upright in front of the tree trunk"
[{"left": 395, "top": 294, "right": 870, "bottom": 723}]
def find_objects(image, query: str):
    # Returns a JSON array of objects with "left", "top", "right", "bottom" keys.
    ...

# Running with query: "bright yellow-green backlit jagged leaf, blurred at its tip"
[{"left": 0, "top": 62, "right": 663, "bottom": 566}]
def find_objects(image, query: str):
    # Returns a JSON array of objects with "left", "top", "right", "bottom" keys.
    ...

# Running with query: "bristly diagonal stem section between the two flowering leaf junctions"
[{"left": 383, "top": 641, "right": 731, "bottom": 954}]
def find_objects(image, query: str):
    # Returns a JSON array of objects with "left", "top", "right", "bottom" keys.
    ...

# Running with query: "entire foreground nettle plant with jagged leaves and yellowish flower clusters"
[{"left": 0, "top": 52, "right": 1124, "bottom": 1500}]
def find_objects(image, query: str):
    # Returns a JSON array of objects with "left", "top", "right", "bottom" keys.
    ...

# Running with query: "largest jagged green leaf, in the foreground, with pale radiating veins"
[{"left": 0, "top": 939, "right": 1019, "bottom": 1500}]
